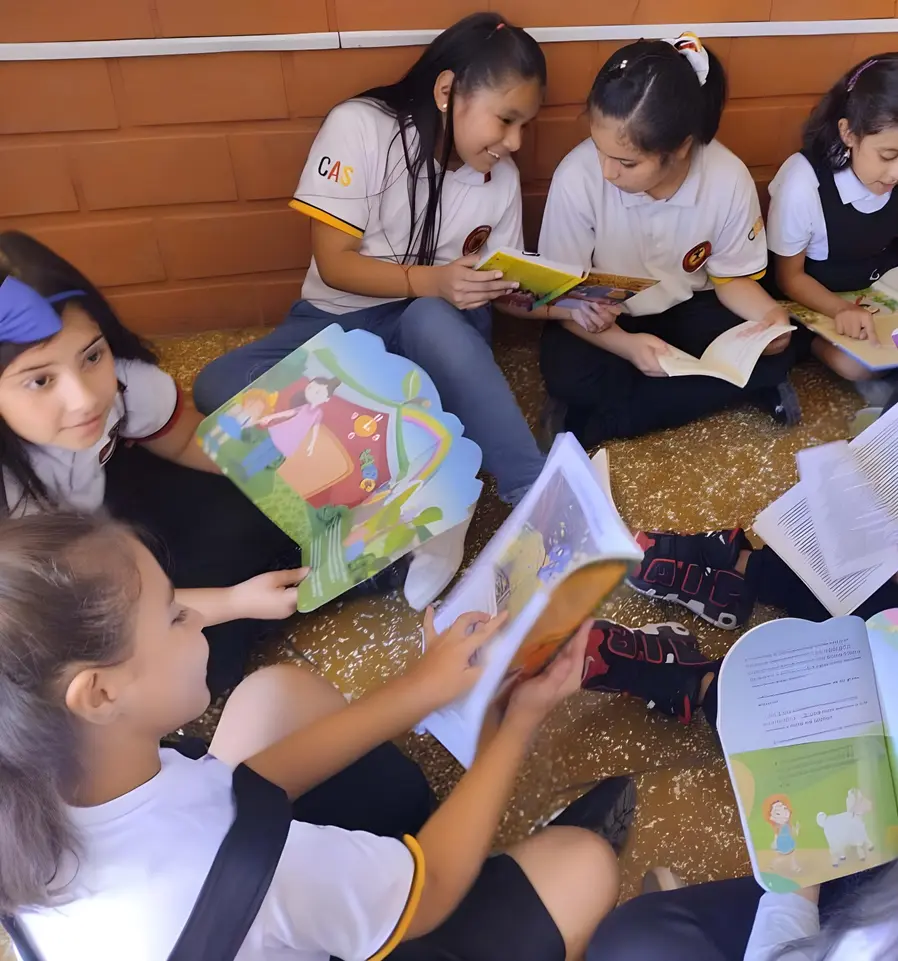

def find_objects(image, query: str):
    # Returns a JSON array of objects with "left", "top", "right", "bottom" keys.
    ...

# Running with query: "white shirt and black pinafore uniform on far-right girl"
[{"left": 767, "top": 153, "right": 898, "bottom": 291}]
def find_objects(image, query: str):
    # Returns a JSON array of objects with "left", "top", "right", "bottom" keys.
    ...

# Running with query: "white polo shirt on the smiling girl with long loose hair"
[{"left": 290, "top": 100, "right": 524, "bottom": 314}]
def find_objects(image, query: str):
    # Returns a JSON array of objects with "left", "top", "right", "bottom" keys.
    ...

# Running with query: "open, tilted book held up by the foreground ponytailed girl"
[{"left": 422, "top": 434, "right": 642, "bottom": 767}]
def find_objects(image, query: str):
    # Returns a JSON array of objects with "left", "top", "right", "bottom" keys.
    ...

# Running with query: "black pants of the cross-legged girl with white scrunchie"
[{"left": 540, "top": 291, "right": 795, "bottom": 447}]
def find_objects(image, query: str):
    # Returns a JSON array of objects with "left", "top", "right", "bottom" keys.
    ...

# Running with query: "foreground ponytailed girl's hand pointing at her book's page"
[{"left": 404, "top": 607, "right": 508, "bottom": 716}]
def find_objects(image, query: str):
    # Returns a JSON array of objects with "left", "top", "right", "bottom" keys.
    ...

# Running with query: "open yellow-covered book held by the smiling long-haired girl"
[{"left": 476, "top": 247, "right": 658, "bottom": 310}]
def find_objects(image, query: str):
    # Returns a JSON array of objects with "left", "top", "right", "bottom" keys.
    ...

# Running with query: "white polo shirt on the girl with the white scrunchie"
[{"left": 539, "top": 140, "right": 767, "bottom": 315}]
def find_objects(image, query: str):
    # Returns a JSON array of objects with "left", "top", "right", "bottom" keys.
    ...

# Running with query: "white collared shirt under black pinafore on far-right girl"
[{"left": 767, "top": 153, "right": 891, "bottom": 260}]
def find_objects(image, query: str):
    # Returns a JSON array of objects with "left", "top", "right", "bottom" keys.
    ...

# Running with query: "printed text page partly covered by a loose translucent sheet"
[{"left": 754, "top": 483, "right": 898, "bottom": 617}]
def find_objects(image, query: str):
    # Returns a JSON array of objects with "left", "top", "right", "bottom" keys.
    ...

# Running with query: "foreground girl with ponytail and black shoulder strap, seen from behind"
[{"left": 0, "top": 514, "right": 632, "bottom": 961}]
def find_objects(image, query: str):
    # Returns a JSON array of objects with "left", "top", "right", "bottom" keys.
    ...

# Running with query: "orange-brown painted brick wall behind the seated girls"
[{"left": 0, "top": 0, "right": 898, "bottom": 333}]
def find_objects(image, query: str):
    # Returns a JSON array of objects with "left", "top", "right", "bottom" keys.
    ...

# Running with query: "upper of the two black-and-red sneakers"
[{"left": 627, "top": 527, "right": 755, "bottom": 631}]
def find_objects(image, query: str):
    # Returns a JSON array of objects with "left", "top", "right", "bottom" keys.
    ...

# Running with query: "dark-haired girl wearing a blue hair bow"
[{"left": 0, "top": 231, "right": 301, "bottom": 696}]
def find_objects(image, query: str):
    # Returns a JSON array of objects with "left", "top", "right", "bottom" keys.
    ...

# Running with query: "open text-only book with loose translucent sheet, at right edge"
[{"left": 754, "top": 406, "right": 898, "bottom": 617}]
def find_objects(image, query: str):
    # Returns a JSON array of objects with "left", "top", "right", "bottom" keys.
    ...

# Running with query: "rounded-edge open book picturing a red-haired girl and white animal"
[{"left": 717, "top": 610, "right": 898, "bottom": 892}]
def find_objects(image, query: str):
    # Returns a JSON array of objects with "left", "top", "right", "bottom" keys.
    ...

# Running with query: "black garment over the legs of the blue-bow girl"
[{"left": 106, "top": 446, "right": 300, "bottom": 697}]
